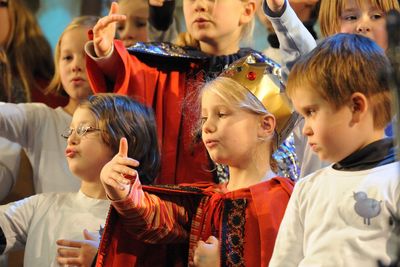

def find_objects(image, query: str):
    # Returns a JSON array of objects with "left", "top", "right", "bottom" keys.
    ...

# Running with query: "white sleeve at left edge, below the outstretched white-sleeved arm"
[{"left": 0, "top": 137, "right": 21, "bottom": 201}]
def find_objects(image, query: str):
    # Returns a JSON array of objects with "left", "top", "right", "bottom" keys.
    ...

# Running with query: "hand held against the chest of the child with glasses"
[{"left": 57, "top": 229, "right": 100, "bottom": 267}]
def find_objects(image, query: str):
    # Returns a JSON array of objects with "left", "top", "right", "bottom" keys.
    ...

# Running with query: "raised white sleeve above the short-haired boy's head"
[{"left": 263, "top": 0, "right": 317, "bottom": 83}]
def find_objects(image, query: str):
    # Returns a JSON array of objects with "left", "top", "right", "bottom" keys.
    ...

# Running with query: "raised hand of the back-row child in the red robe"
[{"left": 93, "top": 2, "right": 126, "bottom": 57}]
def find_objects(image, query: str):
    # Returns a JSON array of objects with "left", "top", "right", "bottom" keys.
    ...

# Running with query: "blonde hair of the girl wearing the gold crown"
[{"left": 197, "top": 76, "right": 278, "bottom": 171}]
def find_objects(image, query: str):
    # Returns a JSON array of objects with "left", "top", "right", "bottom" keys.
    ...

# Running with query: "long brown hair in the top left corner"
[{"left": 1, "top": 0, "right": 54, "bottom": 101}]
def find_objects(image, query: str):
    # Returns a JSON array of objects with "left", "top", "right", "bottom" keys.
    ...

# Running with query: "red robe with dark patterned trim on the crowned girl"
[{"left": 96, "top": 177, "right": 293, "bottom": 267}]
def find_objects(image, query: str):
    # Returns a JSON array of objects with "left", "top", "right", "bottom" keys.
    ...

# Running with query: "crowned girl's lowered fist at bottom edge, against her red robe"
[{"left": 193, "top": 236, "right": 220, "bottom": 267}]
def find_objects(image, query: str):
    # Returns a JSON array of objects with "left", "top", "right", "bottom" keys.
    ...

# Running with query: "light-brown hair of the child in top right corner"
[{"left": 318, "top": 0, "right": 400, "bottom": 37}]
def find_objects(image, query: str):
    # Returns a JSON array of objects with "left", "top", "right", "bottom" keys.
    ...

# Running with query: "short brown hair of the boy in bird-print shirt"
[{"left": 286, "top": 33, "right": 392, "bottom": 129}]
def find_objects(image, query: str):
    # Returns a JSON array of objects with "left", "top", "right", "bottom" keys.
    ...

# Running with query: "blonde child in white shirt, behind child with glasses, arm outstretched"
[{"left": 0, "top": 16, "right": 98, "bottom": 197}]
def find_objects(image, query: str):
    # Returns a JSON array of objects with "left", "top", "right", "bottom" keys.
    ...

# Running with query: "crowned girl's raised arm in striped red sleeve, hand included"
[{"left": 100, "top": 138, "right": 190, "bottom": 243}]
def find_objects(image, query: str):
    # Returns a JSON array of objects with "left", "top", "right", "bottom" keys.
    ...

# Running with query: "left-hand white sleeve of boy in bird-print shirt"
[{"left": 269, "top": 182, "right": 304, "bottom": 267}]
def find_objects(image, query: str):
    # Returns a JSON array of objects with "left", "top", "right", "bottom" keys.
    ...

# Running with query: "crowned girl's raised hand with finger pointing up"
[{"left": 100, "top": 138, "right": 139, "bottom": 200}]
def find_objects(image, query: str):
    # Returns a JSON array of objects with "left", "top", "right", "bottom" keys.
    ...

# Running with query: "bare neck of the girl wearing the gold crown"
[{"left": 227, "top": 165, "right": 276, "bottom": 191}]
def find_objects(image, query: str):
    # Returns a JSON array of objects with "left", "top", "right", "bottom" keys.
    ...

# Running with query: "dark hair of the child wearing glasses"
[{"left": 79, "top": 93, "right": 160, "bottom": 184}]
